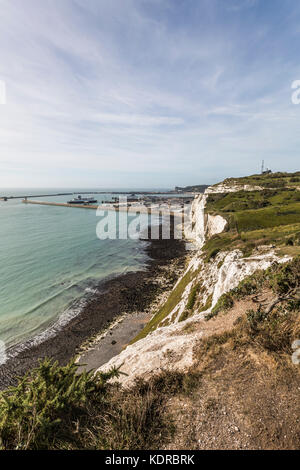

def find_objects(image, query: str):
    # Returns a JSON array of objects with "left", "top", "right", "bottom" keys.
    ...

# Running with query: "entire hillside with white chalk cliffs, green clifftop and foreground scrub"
[{"left": 0, "top": 173, "right": 300, "bottom": 449}]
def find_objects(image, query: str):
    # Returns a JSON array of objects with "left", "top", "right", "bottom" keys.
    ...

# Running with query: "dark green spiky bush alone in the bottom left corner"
[{"left": 0, "top": 359, "right": 119, "bottom": 450}]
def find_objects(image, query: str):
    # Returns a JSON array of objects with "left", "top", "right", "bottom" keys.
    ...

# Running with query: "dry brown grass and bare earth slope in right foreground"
[{"left": 164, "top": 291, "right": 300, "bottom": 449}]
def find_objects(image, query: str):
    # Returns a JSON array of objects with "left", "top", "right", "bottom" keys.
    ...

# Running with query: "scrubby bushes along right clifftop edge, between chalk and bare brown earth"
[{"left": 195, "top": 256, "right": 300, "bottom": 355}]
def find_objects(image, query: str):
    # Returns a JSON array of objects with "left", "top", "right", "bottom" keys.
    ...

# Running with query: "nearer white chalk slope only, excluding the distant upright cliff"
[{"left": 100, "top": 251, "right": 289, "bottom": 385}]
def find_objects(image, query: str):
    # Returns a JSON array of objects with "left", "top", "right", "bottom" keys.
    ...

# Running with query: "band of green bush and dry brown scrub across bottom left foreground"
[{"left": 0, "top": 360, "right": 197, "bottom": 450}]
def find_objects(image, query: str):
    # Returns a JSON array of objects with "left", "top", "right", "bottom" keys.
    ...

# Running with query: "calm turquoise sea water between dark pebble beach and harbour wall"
[{"left": 0, "top": 190, "right": 147, "bottom": 346}]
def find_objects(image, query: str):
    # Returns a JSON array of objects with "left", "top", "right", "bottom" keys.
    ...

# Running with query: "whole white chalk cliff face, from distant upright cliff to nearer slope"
[{"left": 100, "top": 185, "right": 290, "bottom": 384}]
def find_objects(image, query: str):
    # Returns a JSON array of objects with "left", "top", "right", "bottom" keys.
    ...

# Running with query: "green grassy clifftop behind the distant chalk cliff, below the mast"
[{"left": 204, "top": 173, "right": 300, "bottom": 258}]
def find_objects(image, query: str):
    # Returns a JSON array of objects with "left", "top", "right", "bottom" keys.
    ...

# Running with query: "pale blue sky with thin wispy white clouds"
[{"left": 0, "top": 0, "right": 300, "bottom": 188}]
